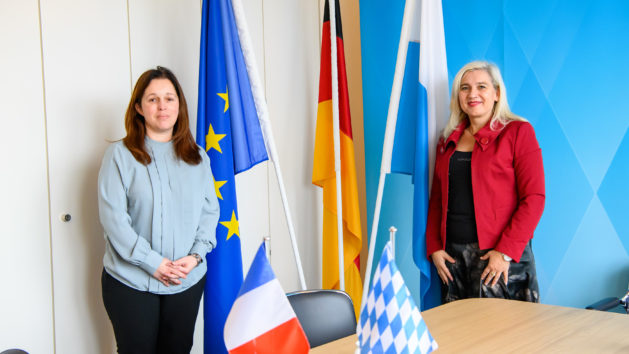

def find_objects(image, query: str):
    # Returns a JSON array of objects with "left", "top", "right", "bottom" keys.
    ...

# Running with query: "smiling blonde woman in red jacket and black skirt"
[{"left": 426, "top": 61, "right": 545, "bottom": 302}]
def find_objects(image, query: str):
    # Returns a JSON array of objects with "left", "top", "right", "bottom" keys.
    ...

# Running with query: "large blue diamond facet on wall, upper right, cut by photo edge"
[{"left": 548, "top": 1, "right": 629, "bottom": 189}]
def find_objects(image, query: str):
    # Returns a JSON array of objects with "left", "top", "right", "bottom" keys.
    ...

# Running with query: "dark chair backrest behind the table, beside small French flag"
[{"left": 286, "top": 290, "right": 356, "bottom": 348}]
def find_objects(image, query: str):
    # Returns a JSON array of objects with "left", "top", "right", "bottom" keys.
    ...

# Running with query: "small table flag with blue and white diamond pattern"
[{"left": 357, "top": 242, "right": 437, "bottom": 354}]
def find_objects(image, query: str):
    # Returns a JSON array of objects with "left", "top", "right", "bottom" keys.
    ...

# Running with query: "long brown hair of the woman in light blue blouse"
[{"left": 122, "top": 66, "right": 201, "bottom": 165}]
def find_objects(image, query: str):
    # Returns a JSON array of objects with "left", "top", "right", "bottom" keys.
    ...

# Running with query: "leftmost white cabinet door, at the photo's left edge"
[{"left": 0, "top": 0, "right": 54, "bottom": 353}]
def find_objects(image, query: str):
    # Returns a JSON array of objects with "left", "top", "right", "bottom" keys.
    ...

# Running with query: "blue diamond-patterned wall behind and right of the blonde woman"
[{"left": 443, "top": 0, "right": 629, "bottom": 307}]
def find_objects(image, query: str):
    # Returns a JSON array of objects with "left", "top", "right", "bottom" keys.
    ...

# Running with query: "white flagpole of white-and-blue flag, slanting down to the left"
[{"left": 361, "top": 0, "right": 416, "bottom": 307}]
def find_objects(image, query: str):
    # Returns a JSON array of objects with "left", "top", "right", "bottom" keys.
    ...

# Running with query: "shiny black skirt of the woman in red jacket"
[{"left": 441, "top": 241, "right": 539, "bottom": 304}]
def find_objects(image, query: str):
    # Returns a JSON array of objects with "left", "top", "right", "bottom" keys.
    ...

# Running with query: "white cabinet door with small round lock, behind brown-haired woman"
[{"left": 40, "top": 0, "right": 131, "bottom": 354}]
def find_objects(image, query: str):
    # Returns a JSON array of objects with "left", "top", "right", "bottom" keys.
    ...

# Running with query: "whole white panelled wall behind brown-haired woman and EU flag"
[{"left": 0, "top": 0, "right": 321, "bottom": 353}]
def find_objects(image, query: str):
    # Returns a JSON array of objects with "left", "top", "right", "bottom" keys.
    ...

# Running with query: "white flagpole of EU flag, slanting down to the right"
[{"left": 231, "top": 0, "right": 306, "bottom": 290}]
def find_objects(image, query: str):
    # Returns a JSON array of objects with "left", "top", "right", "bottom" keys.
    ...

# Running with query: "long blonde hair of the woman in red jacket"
[{"left": 443, "top": 61, "right": 527, "bottom": 139}]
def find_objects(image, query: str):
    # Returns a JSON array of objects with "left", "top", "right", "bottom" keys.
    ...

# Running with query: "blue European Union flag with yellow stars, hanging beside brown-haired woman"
[{"left": 197, "top": 0, "right": 268, "bottom": 353}]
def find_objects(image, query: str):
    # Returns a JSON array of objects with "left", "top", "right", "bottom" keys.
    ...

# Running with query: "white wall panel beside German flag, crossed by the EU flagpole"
[{"left": 264, "top": 0, "right": 322, "bottom": 291}]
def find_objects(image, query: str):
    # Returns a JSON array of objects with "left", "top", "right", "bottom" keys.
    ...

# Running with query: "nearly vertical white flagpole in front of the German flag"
[{"left": 330, "top": 0, "right": 345, "bottom": 291}]
